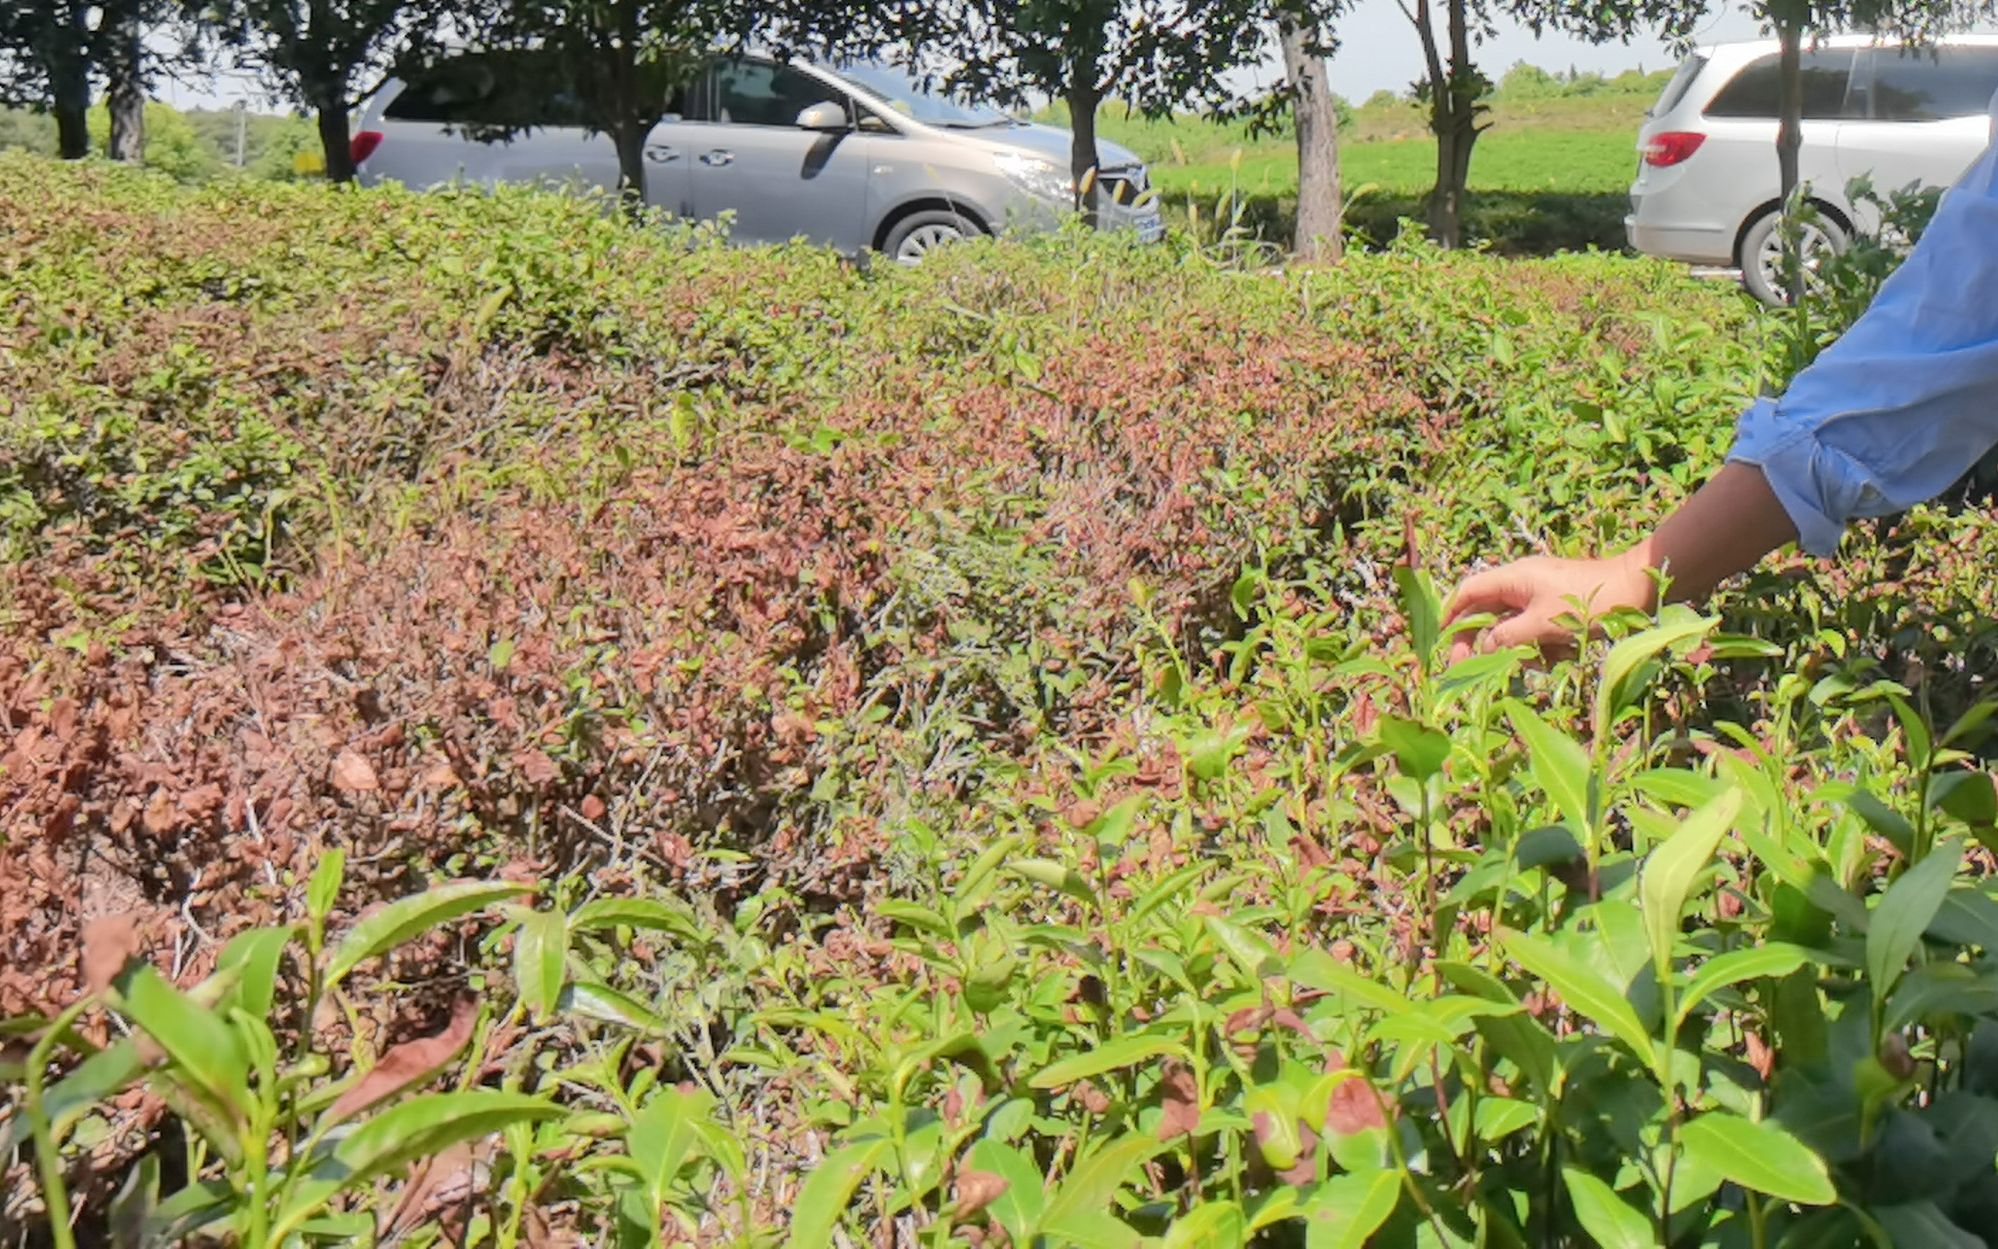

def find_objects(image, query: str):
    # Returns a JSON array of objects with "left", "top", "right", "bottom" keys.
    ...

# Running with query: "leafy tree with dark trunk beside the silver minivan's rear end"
[{"left": 202, "top": 0, "right": 451, "bottom": 182}]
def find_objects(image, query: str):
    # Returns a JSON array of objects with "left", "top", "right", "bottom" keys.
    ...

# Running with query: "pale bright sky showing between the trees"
[{"left": 160, "top": 0, "right": 1758, "bottom": 108}]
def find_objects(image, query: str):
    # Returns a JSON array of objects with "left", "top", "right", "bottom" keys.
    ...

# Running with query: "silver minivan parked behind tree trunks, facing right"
[{"left": 354, "top": 50, "right": 1165, "bottom": 264}]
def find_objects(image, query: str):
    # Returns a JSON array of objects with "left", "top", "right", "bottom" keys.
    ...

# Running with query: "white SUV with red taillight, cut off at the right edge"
[{"left": 1624, "top": 36, "right": 1998, "bottom": 304}]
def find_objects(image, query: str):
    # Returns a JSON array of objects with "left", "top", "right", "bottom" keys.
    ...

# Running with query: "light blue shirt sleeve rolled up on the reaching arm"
[{"left": 1728, "top": 100, "right": 1998, "bottom": 556}]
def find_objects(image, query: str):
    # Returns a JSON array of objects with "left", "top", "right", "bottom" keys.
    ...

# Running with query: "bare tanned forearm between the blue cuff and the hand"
[{"left": 1616, "top": 464, "right": 1796, "bottom": 606}]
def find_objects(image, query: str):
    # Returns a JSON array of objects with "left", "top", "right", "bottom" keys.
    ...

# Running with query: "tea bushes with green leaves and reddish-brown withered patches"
[{"left": 0, "top": 156, "right": 1998, "bottom": 1249}]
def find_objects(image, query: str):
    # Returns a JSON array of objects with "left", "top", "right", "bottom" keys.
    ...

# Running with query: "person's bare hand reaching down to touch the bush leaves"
[{"left": 1445, "top": 554, "right": 1656, "bottom": 661}]
